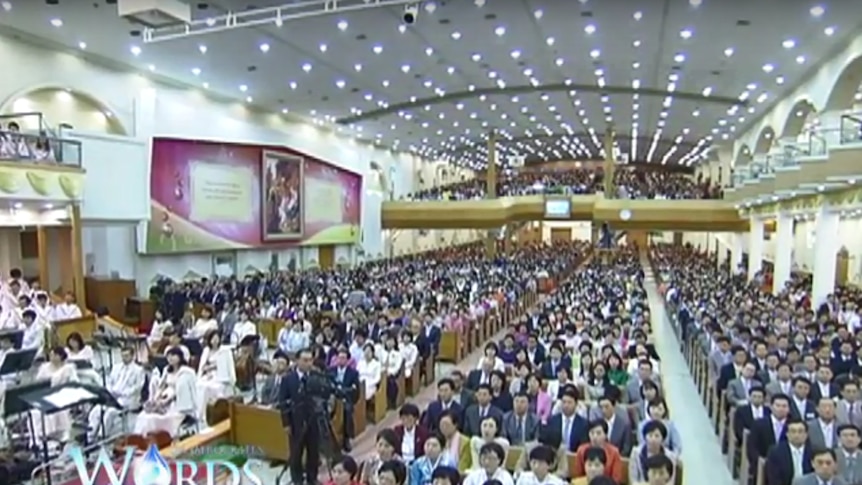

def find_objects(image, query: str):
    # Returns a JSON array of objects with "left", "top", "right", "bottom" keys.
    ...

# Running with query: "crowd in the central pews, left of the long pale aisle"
[{"left": 360, "top": 248, "right": 683, "bottom": 485}]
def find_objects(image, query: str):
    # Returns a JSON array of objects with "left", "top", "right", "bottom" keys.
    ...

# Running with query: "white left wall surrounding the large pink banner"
[{"left": 0, "top": 37, "right": 472, "bottom": 292}]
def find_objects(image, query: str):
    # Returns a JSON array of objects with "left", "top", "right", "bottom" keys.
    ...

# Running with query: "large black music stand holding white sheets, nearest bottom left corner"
[{"left": 19, "top": 382, "right": 122, "bottom": 485}]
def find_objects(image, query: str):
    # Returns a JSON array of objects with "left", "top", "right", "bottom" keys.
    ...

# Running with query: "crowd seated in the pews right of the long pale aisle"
[{"left": 651, "top": 246, "right": 862, "bottom": 485}]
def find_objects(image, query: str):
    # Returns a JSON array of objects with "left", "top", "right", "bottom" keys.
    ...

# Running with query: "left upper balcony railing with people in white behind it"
[{"left": 0, "top": 130, "right": 82, "bottom": 167}]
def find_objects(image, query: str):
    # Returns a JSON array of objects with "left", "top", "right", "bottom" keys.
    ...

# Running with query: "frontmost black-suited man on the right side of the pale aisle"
[{"left": 765, "top": 418, "right": 814, "bottom": 485}]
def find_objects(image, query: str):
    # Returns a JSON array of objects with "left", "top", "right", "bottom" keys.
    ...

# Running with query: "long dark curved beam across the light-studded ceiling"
[{"left": 335, "top": 83, "right": 748, "bottom": 125}]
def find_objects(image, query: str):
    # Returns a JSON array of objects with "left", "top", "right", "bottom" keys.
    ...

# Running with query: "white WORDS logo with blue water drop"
[{"left": 69, "top": 444, "right": 263, "bottom": 485}]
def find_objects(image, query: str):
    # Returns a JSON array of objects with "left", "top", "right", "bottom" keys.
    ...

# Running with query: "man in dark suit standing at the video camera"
[{"left": 278, "top": 348, "right": 323, "bottom": 483}]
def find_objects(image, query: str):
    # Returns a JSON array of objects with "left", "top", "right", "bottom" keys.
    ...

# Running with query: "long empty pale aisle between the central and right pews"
[{"left": 643, "top": 261, "right": 734, "bottom": 485}]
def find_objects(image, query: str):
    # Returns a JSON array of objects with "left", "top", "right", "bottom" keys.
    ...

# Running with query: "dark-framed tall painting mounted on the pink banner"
[{"left": 261, "top": 151, "right": 305, "bottom": 241}]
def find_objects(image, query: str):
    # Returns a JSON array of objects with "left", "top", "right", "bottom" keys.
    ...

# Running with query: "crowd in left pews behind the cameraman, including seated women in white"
[{"left": 118, "top": 242, "right": 588, "bottom": 445}]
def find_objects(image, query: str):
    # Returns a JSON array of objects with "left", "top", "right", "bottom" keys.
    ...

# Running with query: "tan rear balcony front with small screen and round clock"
[{"left": 381, "top": 195, "right": 748, "bottom": 232}]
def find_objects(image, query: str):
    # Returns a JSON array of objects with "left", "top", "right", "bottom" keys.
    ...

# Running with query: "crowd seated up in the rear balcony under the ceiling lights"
[{"left": 407, "top": 168, "right": 722, "bottom": 200}]
